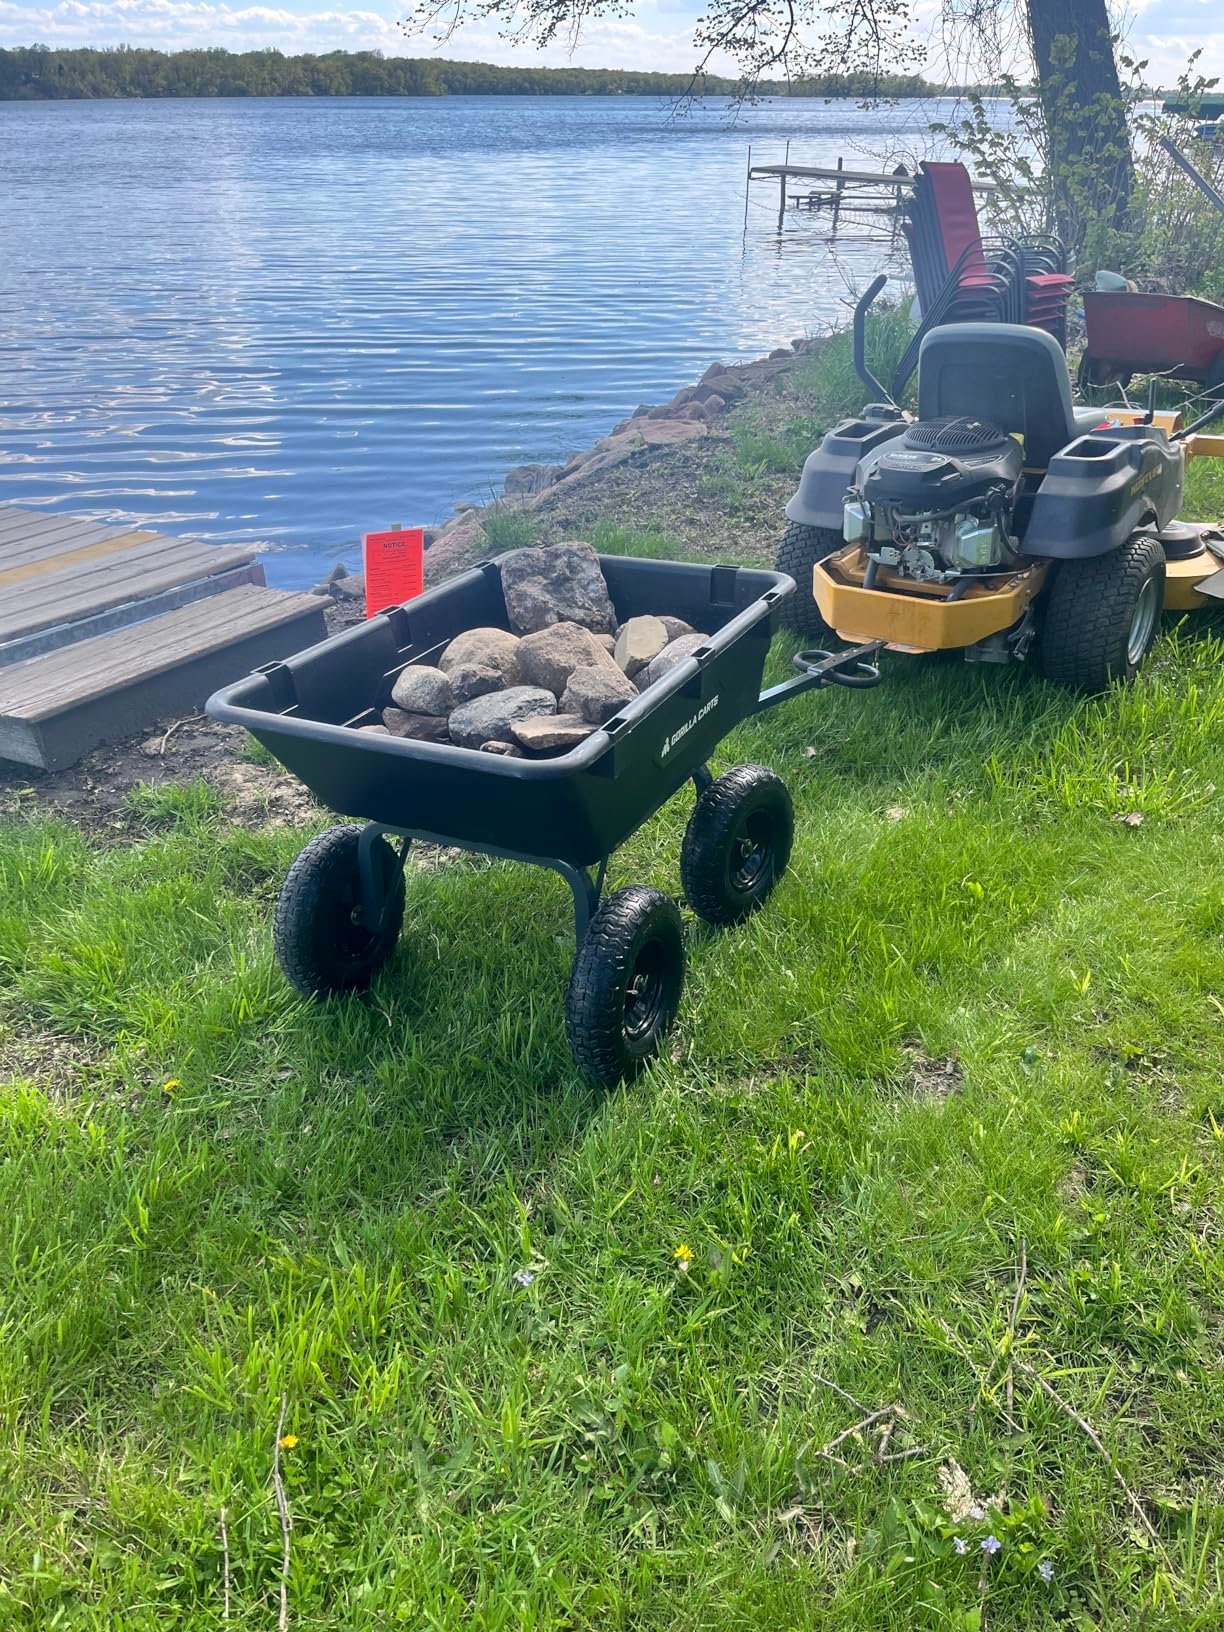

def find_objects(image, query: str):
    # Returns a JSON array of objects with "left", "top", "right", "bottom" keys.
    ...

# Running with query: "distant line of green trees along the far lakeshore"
[{"left": 0, "top": 46, "right": 938, "bottom": 101}]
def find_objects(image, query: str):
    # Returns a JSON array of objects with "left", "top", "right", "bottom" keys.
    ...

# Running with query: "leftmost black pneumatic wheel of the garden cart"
[{"left": 273, "top": 826, "right": 403, "bottom": 997}]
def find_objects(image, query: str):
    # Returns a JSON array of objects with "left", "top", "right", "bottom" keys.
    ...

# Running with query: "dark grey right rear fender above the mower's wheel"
[{"left": 1025, "top": 424, "right": 1185, "bottom": 560}]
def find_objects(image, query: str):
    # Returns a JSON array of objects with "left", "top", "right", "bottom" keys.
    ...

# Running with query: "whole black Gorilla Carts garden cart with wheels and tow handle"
[{"left": 207, "top": 557, "right": 880, "bottom": 1082}]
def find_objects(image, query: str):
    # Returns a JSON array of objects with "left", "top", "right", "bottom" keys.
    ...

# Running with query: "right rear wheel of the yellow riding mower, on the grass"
[{"left": 1038, "top": 532, "right": 1165, "bottom": 694}]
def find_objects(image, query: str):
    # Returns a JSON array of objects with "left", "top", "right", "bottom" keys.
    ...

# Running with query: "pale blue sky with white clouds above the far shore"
[{"left": 0, "top": 0, "right": 1224, "bottom": 83}]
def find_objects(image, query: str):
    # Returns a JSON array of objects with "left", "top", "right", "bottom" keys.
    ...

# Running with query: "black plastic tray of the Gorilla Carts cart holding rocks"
[{"left": 207, "top": 557, "right": 793, "bottom": 867}]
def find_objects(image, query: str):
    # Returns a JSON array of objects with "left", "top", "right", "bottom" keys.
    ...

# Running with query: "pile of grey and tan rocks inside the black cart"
[{"left": 362, "top": 542, "right": 708, "bottom": 757}]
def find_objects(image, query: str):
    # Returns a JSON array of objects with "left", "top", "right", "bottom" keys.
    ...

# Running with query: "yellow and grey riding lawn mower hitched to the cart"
[{"left": 777, "top": 277, "right": 1224, "bottom": 692}]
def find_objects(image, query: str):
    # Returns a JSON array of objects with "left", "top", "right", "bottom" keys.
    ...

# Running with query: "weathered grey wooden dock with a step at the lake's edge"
[{"left": 0, "top": 504, "right": 326, "bottom": 770}]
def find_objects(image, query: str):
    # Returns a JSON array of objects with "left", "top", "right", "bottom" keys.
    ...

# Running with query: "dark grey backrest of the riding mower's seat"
[{"left": 919, "top": 323, "right": 1077, "bottom": 470}]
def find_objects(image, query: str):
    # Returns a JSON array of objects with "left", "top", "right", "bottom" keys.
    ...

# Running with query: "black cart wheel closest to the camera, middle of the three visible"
[{"left": 565, "top": 885, "right": 684, "bottom": 1087}]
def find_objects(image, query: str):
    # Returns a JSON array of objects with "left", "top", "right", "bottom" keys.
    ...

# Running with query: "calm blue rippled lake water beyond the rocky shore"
[{"left": 0, "top": 96, "right": 937, "bottom": 584}]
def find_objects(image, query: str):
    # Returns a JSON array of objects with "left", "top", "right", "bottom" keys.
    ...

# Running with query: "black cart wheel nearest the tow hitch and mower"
[{"left": 681, "top": 765, "right": 795, "bottom": 925}]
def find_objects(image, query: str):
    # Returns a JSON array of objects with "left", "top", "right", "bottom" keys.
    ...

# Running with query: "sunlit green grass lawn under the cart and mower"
[{"left": 0, "top": 478, "right": 1224, "bottom": 1632}]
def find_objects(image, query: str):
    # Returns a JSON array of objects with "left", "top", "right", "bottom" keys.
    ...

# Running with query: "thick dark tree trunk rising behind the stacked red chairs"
[{"left": 1027, "top": 0, "right": 1134, "bottom": 250}]
